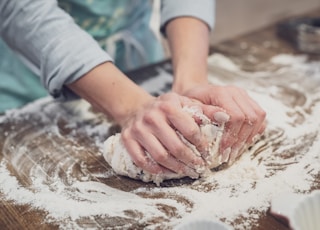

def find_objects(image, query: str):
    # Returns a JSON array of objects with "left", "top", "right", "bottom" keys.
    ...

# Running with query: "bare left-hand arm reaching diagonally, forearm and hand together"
[{"left": 67, "top": 62, "right": 229, "bottom": 177}]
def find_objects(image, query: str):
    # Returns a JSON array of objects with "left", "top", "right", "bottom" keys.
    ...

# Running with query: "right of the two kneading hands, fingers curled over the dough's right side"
[{"left": 184, "top": 84, "right": 266, "bottom": 162}]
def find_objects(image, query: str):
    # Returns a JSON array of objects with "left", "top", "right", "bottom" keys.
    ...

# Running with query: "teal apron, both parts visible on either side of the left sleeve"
[{"left": 0, "top": 0, "right": 164, "bottom": 113}]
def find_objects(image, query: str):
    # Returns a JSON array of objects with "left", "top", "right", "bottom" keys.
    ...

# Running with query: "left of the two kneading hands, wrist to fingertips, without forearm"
[{"left": 121, "top": 93, "right": 228, "bottom": 178}]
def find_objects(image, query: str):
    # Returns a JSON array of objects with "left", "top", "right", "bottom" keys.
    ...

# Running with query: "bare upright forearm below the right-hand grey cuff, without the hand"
[{"left": 166, "top": 17, "right": 209, "bottom": 93}]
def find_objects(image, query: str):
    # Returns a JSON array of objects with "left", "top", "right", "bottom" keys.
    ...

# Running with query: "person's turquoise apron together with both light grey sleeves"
[{"left": 0, "top": 0, "right": 214, "bottom": 112}]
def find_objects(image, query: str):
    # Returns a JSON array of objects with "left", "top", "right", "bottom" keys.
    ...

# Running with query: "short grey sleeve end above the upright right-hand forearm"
[{"left": 160, "top": 0, "right": 215, "bottom": 35}]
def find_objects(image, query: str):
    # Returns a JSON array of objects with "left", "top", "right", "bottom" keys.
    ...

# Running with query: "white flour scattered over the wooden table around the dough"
[{"left": 0, "top": 55, "right": 320, "bottom": 229}]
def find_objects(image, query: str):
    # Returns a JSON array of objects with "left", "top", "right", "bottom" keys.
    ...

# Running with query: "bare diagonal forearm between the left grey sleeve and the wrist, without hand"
[{"left": 68, "top": 62, "right": 153, "bottom": 125}]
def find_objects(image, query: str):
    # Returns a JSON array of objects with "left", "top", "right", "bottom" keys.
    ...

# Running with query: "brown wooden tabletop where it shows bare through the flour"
[{"left": 0, "top": 11, "right": 320, "bottom": 230}]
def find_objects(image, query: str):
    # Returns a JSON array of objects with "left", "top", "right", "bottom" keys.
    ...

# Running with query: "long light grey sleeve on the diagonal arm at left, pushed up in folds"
[{"left": 0, "top": 0, "right": 112, "bottom": 99}]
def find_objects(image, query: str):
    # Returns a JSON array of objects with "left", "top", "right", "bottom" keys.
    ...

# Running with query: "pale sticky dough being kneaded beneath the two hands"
[{"left": 103, "top": 107, "right": 228, "bottom": 185}]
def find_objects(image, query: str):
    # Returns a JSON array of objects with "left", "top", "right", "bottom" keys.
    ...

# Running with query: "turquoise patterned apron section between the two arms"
[{"left": 58, "top": 0, "right": 164, "bottom": 71}]
